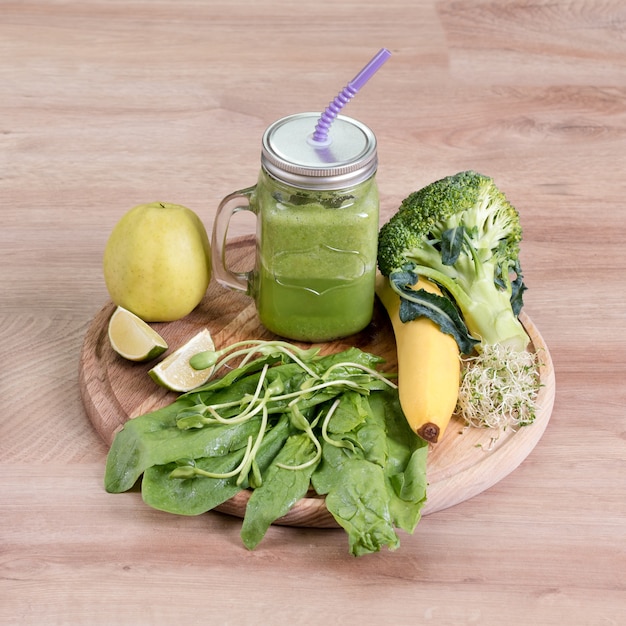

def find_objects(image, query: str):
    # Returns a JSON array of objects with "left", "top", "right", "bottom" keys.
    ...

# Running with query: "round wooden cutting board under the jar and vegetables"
[{"left": 79, "top": 238, "right": 555, "bottom": 528}]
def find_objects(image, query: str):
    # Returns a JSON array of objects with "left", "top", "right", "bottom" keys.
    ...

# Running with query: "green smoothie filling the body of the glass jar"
[{"left": 254, "top": 173, "right": 378, "bottom": 342}]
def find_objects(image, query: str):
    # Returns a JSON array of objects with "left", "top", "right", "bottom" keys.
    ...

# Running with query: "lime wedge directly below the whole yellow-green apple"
[{"left": 109, "top": 306, "right": 167, "bottom": 361}]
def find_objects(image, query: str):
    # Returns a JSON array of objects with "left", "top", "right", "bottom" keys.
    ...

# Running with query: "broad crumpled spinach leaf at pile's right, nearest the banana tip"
[{"left": 311, "top": 390, "right": 427, "bottom": 556}]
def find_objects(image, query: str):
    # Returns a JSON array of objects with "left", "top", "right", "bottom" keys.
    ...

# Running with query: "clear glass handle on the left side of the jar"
[{"left": 211, "top": 186, "right": 256, "bottom": 295}]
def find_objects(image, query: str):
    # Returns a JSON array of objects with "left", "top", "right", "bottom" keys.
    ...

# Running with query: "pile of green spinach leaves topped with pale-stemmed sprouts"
[{"left": 105, "top": 341, "right": 427, "bottom": 556}]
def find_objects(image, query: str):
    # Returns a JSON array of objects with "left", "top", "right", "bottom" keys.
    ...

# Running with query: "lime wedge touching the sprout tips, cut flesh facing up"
[{"left": 148, "top": 328, "right": 215, "bottom": 392}]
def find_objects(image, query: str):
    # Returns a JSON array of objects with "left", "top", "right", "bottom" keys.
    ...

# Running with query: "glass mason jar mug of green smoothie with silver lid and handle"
[{"left": 212, "top": 113, "right": 379, "bottom": 342}]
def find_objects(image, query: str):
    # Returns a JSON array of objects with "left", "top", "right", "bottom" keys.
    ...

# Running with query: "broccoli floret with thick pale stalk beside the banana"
[{"left": 378, "top": 171, "right": 529, "bottom": 353}]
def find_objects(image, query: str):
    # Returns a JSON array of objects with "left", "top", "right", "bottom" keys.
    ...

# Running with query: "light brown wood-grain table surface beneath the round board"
[{"left": 0, "top": 0, "right": 626, "bottom": 626}]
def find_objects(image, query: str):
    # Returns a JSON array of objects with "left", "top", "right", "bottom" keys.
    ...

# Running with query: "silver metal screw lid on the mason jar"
[{"left": 261, "top": 113, "right": 378, "bottom": 189}]
